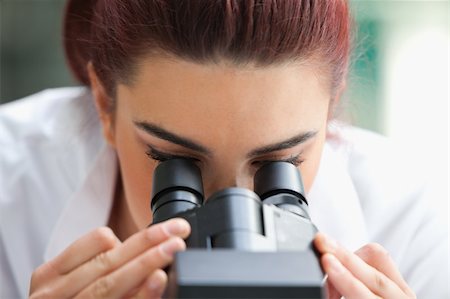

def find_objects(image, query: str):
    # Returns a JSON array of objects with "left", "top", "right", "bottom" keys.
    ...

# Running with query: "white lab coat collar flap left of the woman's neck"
[{"left": 44, "top": 143, "right": 118, "bottom": 261}]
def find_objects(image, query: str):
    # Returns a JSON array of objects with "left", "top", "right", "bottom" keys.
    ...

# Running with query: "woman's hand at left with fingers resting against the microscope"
[{"left": 30, "top": 219, "right": 190, "bottom": 298}]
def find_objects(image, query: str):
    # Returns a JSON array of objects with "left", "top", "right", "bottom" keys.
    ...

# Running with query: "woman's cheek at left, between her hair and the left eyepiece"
[{"left": 116, "top": 117, "right": 156, "bottom": 228}]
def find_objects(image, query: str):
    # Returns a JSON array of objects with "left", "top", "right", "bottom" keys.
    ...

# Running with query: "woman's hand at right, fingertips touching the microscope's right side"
[{"left": 314, "top": 233, "right": 416, "bottom": 299}]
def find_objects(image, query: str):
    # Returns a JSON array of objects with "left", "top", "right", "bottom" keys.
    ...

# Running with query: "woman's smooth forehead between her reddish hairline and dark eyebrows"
[{"left": 117, "top": 58, "right": 330, "bottom": 145}]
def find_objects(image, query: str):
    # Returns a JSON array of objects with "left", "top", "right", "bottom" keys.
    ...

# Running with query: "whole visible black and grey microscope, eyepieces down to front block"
[{"left": 151, "top": 159, "right": 325, "bottom": 298}]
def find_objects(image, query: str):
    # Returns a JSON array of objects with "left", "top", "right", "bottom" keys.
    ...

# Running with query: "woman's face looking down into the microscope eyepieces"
[{"left": 94, "top": 58, "right": 330, "bottom": 232}]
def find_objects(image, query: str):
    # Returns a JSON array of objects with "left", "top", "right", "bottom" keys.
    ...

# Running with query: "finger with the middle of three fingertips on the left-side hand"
[{"left": 76, "top": 237, "right": 186, "bottom": 298}]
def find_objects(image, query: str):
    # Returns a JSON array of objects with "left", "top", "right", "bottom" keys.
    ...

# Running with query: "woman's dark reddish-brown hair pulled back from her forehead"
[{"left": 64, "top": 0, "right": 349, "bottom": 96}]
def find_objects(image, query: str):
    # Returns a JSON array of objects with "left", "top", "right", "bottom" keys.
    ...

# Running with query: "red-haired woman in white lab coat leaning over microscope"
[{"left": 0, "top": 0, "right": 448, "bottom": 298}]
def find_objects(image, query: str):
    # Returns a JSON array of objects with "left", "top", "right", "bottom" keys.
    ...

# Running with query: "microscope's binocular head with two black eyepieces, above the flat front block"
[{"left": 151, "top": 159, "right": 315, "bottom": 251}]
